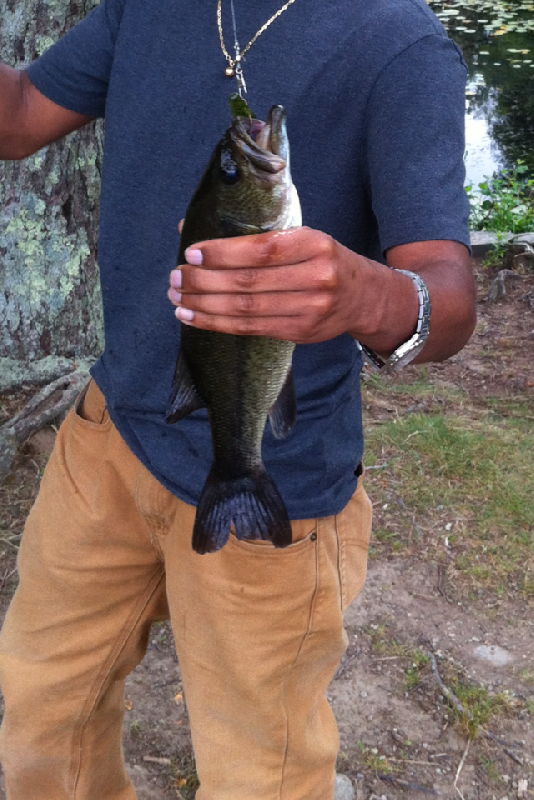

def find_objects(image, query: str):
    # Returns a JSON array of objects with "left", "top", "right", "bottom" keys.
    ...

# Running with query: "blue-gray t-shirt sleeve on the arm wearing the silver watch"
[{"left": 366, "top": 34, "right": 469, "bottom": 252}]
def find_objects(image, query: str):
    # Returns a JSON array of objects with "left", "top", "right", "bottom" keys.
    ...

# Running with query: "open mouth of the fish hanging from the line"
[{"left": 230, "top": 106, "right": 289, "bottom": 177}]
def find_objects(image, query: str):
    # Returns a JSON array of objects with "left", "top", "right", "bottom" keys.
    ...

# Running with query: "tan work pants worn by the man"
[{"left": 0, "top": 382, "right": 371, "bottom": 800}]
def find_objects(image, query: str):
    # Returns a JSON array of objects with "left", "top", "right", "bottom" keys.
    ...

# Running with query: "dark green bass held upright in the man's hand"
[{"left": 167, "top": 106, "right": 302, "bottom": 553}]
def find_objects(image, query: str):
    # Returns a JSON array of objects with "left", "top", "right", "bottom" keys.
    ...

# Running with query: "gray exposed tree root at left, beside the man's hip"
[{"left": 0, "top": 369, "right": 90, "bottom": 484}]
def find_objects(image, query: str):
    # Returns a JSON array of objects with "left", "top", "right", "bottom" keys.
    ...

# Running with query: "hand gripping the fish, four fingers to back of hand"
[{"left": 168, "top": 228, "right": 357, "bottom": 344}]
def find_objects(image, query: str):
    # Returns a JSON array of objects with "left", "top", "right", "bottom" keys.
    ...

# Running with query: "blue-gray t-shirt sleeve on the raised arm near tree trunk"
[{"left": 27, "top": 0, "right": 125, "bottom": 117}]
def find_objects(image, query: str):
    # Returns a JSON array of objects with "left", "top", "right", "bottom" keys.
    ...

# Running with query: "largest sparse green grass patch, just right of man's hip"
[{"left": 366, "top": 412, "right": 534, "bottom": 599}]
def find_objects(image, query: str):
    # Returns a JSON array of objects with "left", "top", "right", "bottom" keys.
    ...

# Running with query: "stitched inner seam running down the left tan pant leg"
[{"left": 69, "top": 566, "right": 165, "bottom": 800}]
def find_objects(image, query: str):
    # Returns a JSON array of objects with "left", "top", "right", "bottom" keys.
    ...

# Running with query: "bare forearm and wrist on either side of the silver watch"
[{"left": 351, "top": 242, "right": 476, "bottom": 363}]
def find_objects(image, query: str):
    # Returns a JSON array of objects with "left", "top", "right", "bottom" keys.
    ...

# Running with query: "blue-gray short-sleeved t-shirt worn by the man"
[{"left": 29, "top": 0, "right": 469, "bottom": 519}]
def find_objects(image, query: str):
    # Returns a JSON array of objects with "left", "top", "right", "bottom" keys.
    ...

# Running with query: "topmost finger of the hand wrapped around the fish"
[{"left": 186, "top": 228, "right": 335, "bottom": 270}]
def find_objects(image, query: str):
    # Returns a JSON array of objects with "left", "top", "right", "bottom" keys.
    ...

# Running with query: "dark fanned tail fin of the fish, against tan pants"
[{"left": 193, "top": 467, "right": 292, "bottom": 553}]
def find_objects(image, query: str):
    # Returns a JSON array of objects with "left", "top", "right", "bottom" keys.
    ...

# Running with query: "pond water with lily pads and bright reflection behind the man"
[{"left": 429, "top": 0, "right": 534, "bottom": 185}]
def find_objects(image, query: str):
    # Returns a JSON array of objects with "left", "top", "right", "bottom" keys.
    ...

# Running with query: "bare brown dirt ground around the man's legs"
[{"left": 0, "top": 261, "right": 534, "bottom": 800}]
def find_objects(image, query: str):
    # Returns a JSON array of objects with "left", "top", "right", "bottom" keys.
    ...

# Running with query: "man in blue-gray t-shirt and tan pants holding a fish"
[{"left": 0, "top": 0, "right": 474, "bottom": 800}]
